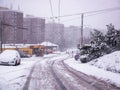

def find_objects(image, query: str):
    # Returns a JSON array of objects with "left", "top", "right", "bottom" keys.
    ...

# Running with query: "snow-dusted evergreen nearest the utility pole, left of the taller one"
[{"left": 90, "top": 29, "right": 111, "bottom": 58}]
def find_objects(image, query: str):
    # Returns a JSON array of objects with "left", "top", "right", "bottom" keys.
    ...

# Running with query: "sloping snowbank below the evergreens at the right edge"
[{"left": 89, "top": 51, "right": 120, "bottom": 73}]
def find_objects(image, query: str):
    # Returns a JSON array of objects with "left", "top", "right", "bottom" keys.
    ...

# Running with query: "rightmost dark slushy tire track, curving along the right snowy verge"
[{"left": 61, "top": 60, "right": 120, "bottom": 90}]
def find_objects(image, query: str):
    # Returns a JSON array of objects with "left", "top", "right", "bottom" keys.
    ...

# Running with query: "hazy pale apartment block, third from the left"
[{"left": 45, "top": 23, "right": 64, "bottom": 50}]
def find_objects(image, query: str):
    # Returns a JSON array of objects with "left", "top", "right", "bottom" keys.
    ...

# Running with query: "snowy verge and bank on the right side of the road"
[{"left": 65, "top": 51, "right": 120, "bottom": 87}]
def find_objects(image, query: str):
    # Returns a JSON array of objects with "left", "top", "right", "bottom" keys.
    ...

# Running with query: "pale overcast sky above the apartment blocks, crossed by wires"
[{"left": 0, "top": 0, "right": 120, "bottom": 29}]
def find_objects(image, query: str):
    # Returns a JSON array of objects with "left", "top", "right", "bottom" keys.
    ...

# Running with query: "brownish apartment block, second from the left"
[{"left": 23, "top": 16, "right": 45, "bottom": 44}]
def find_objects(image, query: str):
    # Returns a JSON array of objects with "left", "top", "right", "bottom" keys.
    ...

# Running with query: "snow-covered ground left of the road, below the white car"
[{"left": 0, "top": 57, "right": 41, "bottom": 90}]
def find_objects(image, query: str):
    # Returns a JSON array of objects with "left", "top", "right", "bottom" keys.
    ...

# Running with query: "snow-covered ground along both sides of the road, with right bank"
[{"left": 0, "top": 51, "right": 120, "bottom": 90}]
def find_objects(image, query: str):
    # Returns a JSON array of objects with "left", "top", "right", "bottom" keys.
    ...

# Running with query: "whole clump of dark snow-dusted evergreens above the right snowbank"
[{"left": 79, "top": 24, "right": 120, "bottom": 61}]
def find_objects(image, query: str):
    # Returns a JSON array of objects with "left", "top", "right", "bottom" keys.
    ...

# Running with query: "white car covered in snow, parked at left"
[{"left": 0, "top": 50, "right": 21, "bottom": 66}]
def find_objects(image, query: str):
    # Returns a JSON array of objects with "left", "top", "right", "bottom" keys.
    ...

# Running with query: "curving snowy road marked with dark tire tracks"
[{"left": 22, "top": 55, "right": 119, "bottom": 90}]
